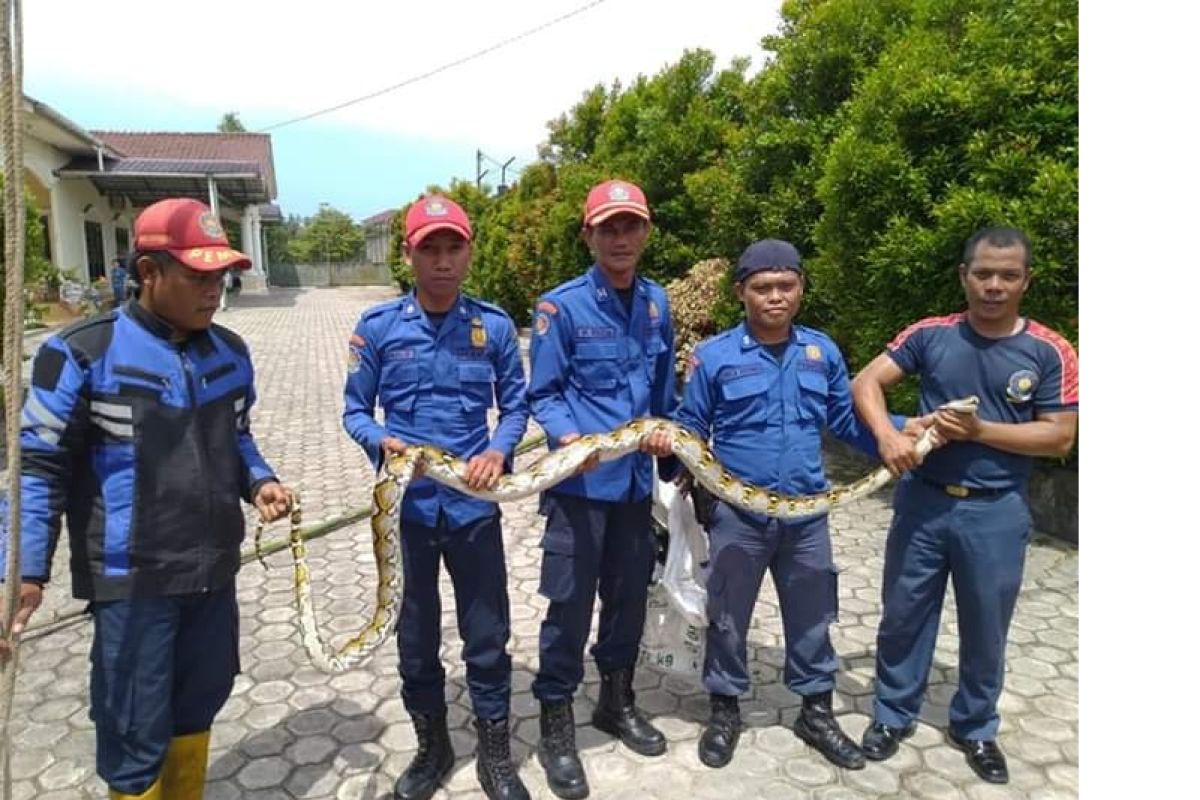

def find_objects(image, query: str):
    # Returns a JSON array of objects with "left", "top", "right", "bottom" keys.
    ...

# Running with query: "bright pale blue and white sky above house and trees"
[{"left": 24, "top": 0, "right": 780, "bottom": 219}]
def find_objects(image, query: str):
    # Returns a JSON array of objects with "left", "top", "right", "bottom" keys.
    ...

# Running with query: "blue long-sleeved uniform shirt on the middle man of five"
[{"left": 529, "top": 265, "right": 677, "bottom": 503}]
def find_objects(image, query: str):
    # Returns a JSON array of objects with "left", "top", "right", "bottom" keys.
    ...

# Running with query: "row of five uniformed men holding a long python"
[{"left": 4, "top": 180, "right": 1078, "bottom": 800}]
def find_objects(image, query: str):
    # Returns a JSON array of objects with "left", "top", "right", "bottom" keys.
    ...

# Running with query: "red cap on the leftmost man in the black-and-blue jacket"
[{"left": 133, "top": 197, "right": 250, "bottom": 272}]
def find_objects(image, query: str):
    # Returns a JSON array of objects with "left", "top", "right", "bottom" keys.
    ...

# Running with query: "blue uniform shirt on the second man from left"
[{"left": 342, "top": 295, "right": 529, "bottom": 528}]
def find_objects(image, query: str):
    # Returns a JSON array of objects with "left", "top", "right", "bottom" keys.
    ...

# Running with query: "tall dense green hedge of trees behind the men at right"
[{"left": 379, "top": 0, "right": 1079, "bottom": 388}]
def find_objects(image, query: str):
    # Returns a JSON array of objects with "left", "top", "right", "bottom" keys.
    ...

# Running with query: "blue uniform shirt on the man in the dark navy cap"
[{"left": 676, "top": 323, "right": 904, "bottom": 494}]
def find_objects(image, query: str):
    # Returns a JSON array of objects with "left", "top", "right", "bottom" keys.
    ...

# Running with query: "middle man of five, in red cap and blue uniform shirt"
[{"left": 529, "top": 180, "right": 678, "bottom": 798}]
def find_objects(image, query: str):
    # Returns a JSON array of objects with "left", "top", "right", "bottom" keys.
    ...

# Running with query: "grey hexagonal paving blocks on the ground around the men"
[{"left": 11, "top": 289, "right": 1079, "bottom": 800}]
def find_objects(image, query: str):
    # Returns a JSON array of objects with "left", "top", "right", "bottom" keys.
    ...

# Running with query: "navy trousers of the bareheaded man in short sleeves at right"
[{"left": 875, "top": 475, "right": 1032, "bottom": 740}]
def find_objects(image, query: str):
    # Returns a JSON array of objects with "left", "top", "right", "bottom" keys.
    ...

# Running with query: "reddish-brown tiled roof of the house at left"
[{"left": 91, "top": 131, "right": 278, "bottom": 198}]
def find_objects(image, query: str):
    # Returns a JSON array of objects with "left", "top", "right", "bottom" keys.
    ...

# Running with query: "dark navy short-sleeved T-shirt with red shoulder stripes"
[{"left": 887, "top": 313, "right": 1079, "bottom": 489}]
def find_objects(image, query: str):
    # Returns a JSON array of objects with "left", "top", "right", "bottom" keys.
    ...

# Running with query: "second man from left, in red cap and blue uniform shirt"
[{"left": 342, "top": 196, "right": 529, "bottom": 800}]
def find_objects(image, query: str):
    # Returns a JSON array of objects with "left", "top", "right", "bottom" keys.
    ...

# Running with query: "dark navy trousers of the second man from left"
[{"left": 396, "top": 512, "right": 512, "bottom": 720}]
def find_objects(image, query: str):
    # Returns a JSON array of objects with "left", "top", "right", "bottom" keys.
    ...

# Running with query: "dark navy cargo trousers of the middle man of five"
[{"left": 533, "top": 493, "right": 654, "bottom": 703}]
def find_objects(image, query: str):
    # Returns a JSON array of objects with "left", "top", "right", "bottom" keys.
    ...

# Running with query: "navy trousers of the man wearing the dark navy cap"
[{"left": 703, "top": 501, "right": 838, "bottom": 697}]
